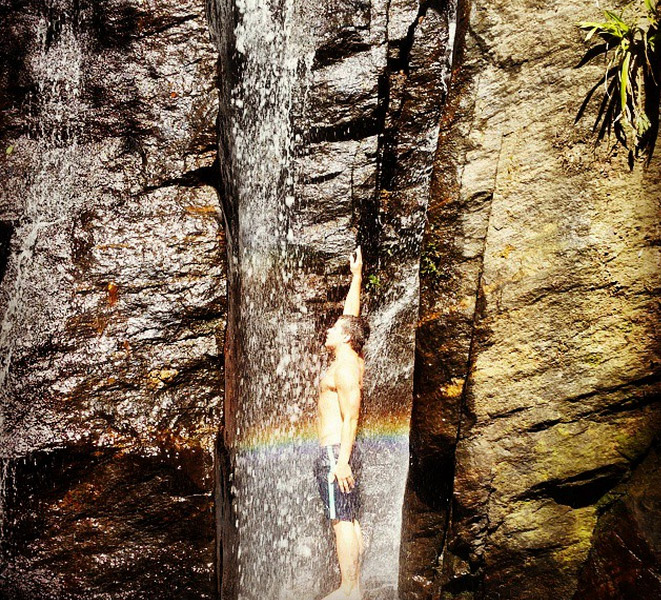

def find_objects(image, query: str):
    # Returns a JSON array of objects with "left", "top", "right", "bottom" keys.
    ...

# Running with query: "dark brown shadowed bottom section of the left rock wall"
[{"left": 0, "top": 445, "right": 214, "bottom": 600}]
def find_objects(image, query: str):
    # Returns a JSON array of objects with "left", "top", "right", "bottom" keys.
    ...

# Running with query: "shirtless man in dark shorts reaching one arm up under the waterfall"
[{"left": 315, "top": 246, "right": 369, "bottom": 600}]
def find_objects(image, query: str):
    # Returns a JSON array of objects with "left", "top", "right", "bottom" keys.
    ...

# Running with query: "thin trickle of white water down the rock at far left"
[{"left": 0, "top": 0, "right": 87, "bottom": 543}]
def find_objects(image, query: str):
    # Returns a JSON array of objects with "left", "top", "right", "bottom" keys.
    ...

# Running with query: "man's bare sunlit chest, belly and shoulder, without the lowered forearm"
[{"left": 317, "top": 356, "right": 365, "bottom": 446}]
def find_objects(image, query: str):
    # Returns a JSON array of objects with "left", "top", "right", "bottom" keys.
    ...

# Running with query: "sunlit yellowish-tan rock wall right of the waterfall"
[{"left": 410, "top": 2, "right": 661, "bottom": 600}]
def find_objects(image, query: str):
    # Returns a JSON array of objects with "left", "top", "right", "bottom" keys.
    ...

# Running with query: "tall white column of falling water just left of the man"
[{"left": 214, "top": 0, "right": 328, "bottom": 600}]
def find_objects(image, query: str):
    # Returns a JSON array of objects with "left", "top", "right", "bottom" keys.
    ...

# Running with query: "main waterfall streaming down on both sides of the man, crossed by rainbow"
[{"left": 209, "top": 0, "right": 454, "bottom": 600}]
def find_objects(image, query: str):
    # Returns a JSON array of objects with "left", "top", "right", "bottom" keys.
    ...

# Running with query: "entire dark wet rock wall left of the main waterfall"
[{"left": 0, "top": 0, "right": 225, "bottom": 599}]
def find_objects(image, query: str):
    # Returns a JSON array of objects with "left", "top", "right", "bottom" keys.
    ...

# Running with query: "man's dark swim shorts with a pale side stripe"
[{"left": 314, "top": 443, "right": 362, "bottom": 521}]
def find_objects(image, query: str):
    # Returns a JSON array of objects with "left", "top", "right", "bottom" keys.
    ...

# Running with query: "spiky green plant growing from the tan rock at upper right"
[{"left": 574, "top": 0, "right": 661, "bottom": 167}]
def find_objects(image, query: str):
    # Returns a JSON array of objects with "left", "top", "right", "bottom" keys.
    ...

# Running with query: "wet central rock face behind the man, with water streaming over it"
[{"left": 209, "top": 1, "right": 455, "bottom": 598}]
